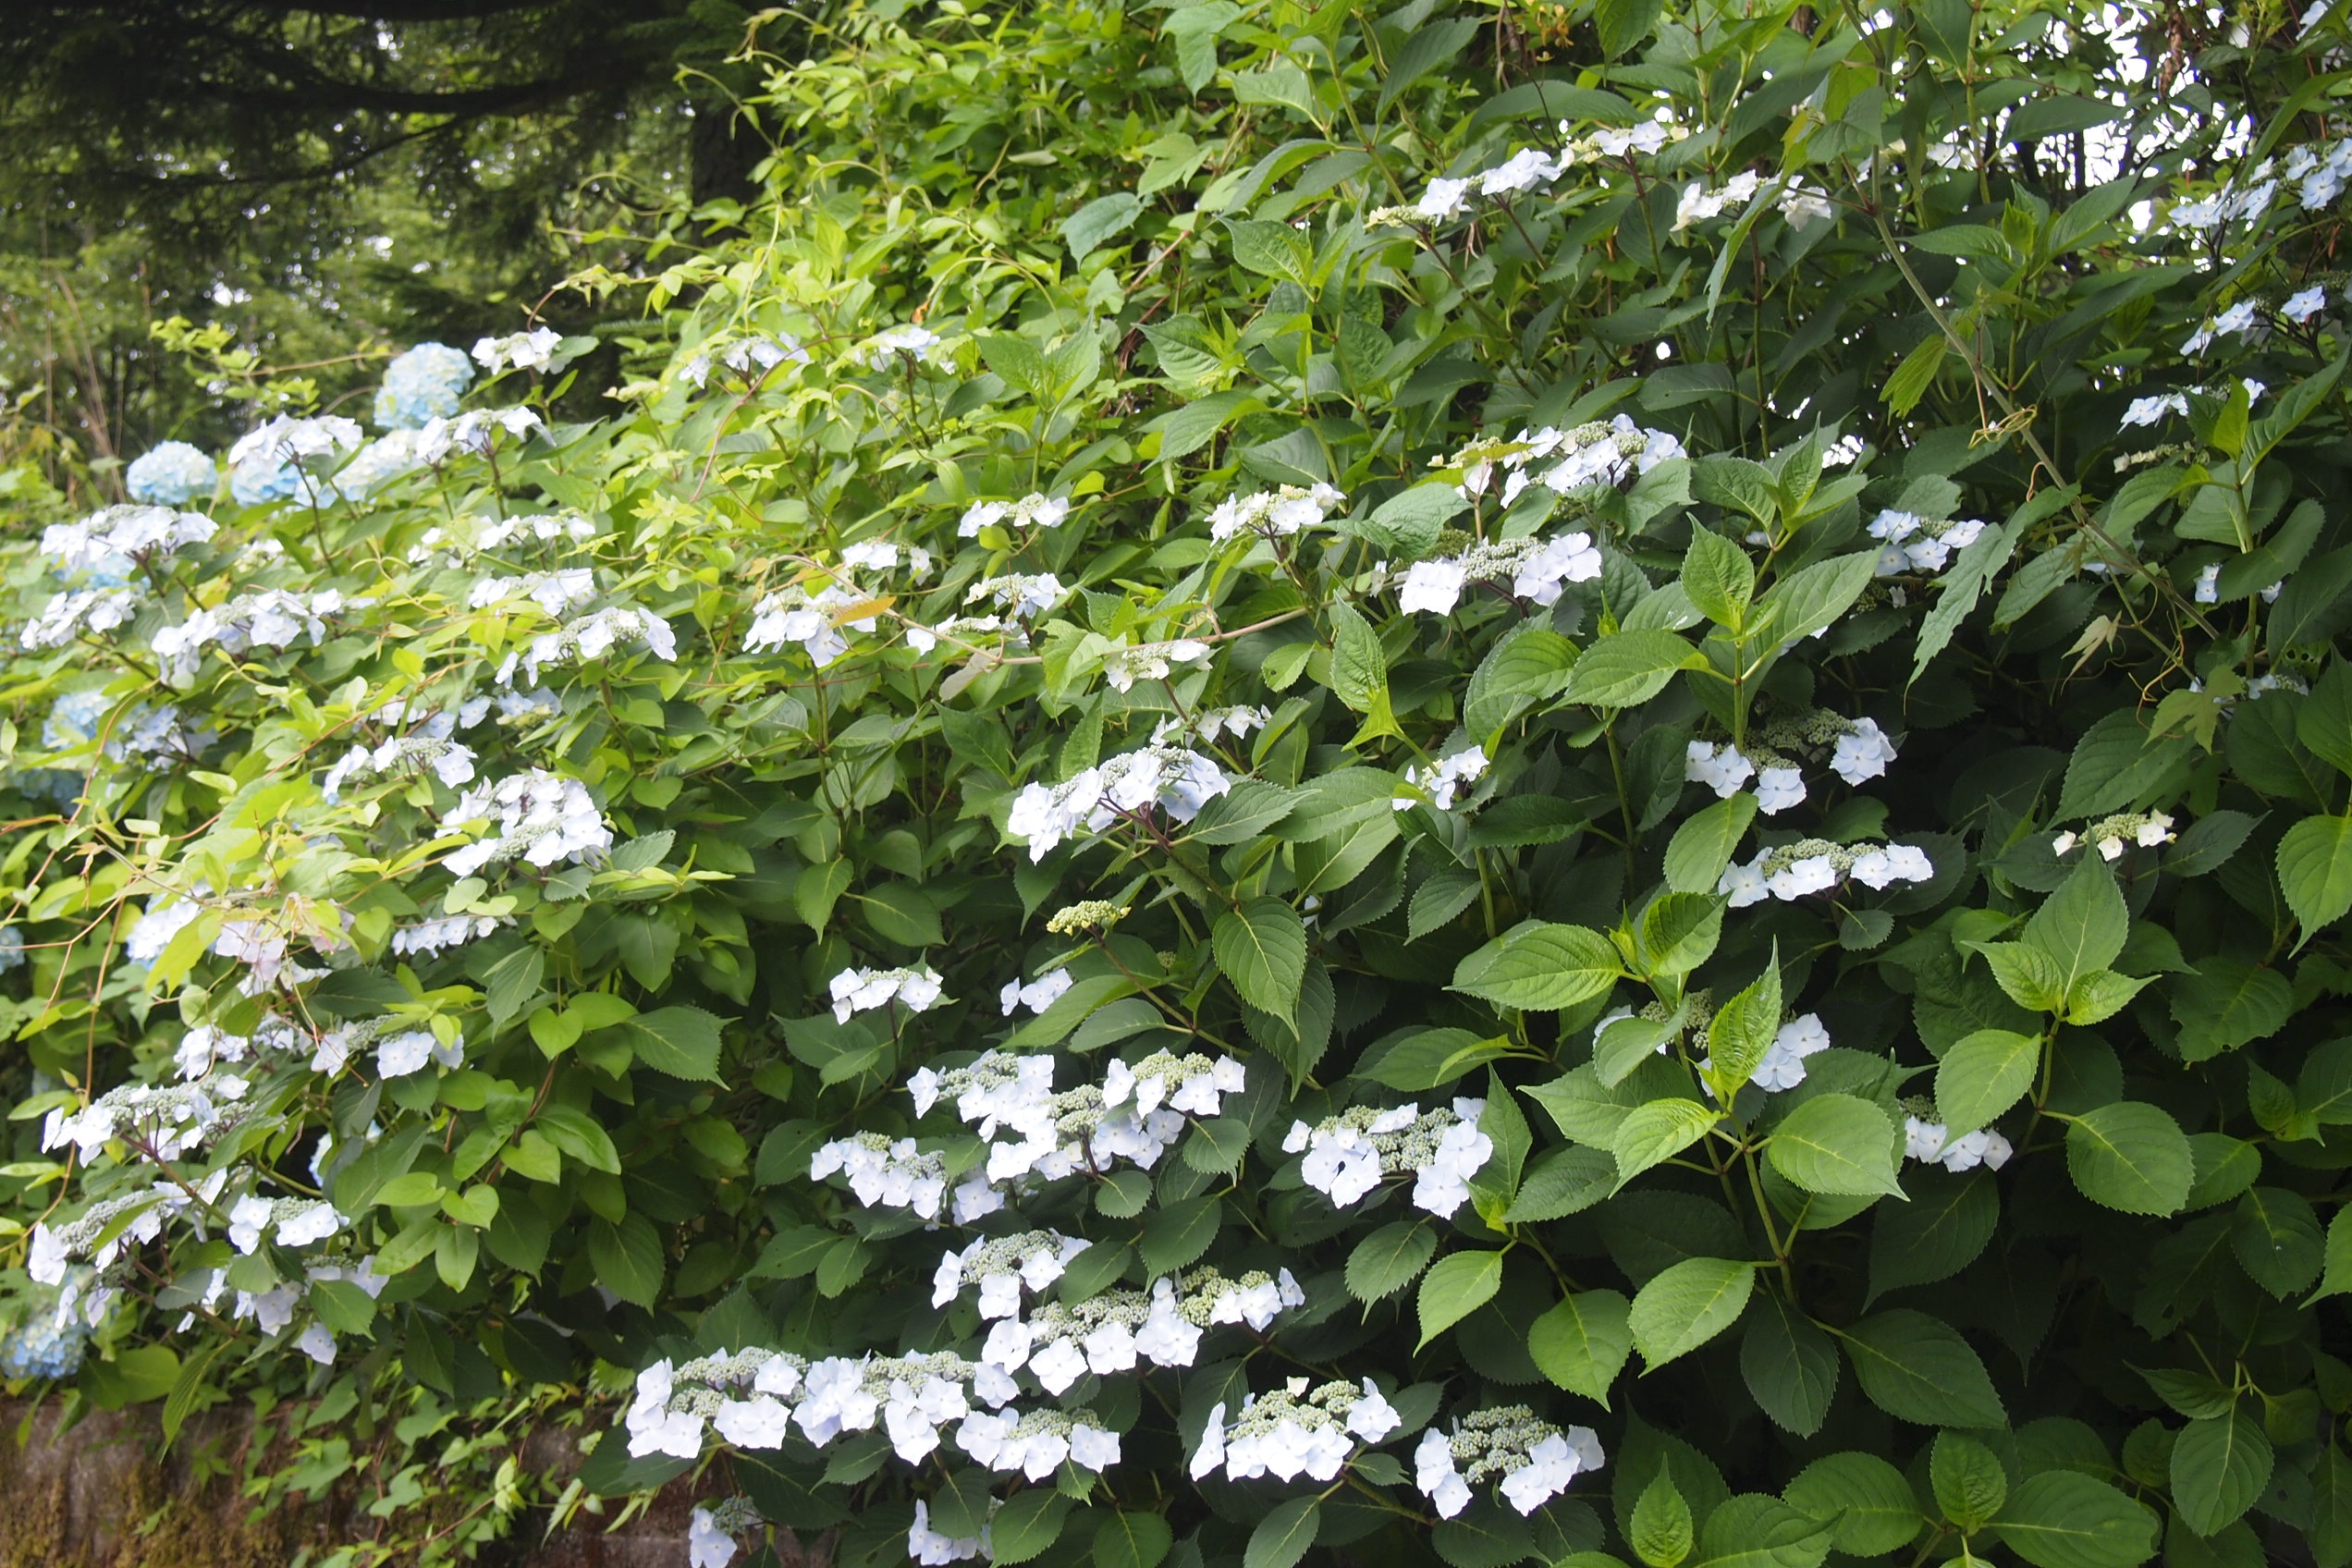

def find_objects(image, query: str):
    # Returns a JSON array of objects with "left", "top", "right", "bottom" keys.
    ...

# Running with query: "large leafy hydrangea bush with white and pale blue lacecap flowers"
[{"left": 0, "top": 0, "right": 2352, "bottom": 1568}]
